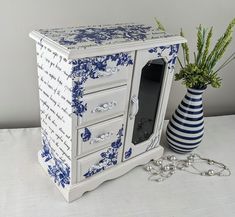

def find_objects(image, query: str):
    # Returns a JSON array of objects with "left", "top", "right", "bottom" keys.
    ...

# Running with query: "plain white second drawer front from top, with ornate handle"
[{"left": 78, "top": 85, "right": 128, "bottom": 125}]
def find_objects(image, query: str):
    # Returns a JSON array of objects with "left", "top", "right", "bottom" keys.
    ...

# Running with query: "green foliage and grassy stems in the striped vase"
[{"left": 156, "top": 18, "right": 235, "bottom": 89}]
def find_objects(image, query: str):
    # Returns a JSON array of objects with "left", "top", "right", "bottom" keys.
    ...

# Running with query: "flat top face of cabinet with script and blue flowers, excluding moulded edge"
[{"left": 38, "top": 23, "right": 172, "bottom": 50}]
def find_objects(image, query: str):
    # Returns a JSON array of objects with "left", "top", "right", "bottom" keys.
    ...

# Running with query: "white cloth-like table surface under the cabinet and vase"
[{"left": 0, "top": 115, "right": 235, "bottom": 217}]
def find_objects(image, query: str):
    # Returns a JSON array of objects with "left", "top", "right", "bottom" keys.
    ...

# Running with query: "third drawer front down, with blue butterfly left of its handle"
[{"left": 77, "top": 116, "right": 123, "bottom": 155}]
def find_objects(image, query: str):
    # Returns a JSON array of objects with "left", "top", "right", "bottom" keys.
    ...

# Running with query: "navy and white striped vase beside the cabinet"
[{"left": 166, "top": 88, "right": 206, "bottom": 153}]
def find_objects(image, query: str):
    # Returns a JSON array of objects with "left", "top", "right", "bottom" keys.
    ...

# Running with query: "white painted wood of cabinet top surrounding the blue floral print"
[{"left": 30, "top": 23, "right": 186, "bottom": 60}]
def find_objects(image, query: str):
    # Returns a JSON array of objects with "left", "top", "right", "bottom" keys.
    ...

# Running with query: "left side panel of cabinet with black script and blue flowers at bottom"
[{"left": 36, "top": 43, "right": 72, "bottom": 187}]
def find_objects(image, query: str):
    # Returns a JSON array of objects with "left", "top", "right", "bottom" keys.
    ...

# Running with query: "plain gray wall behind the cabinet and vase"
[{"left": 0, "top": 0, "right": 235, "bottom": 128}]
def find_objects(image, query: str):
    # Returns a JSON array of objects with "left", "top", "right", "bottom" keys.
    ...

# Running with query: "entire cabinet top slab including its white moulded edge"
[{"left": 29, "top": 23, "right": 186, "bottom": 59}]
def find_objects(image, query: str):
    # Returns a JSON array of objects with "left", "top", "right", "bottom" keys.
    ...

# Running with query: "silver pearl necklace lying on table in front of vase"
[{"left": 145, "top": 154, "right": 231, "bottom": 182}]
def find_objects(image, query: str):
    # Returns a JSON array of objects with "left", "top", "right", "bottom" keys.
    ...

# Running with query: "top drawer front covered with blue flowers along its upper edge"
[{"left": 72, "top": 52, "right": 134, "bottom": 94}]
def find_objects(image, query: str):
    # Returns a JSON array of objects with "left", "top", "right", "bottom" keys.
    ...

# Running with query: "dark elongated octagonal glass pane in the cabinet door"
[{"left": 132, "top": 59, "right": 165, "bottom": 145}]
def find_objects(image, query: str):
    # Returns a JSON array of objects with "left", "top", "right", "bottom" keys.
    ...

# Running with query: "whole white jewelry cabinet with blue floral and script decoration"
[{"left": 30, "top": 24, "right": 185, "bottom": 201}]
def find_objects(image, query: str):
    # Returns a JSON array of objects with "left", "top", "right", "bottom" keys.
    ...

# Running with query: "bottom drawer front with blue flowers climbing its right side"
[{"left": 77, "top": 127, "right": 123, "bottom": 182}]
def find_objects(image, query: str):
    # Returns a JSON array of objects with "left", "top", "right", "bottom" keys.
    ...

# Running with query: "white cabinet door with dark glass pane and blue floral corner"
[{"left": 123, "top": 45, "right": 178, "bottom": 160}]
